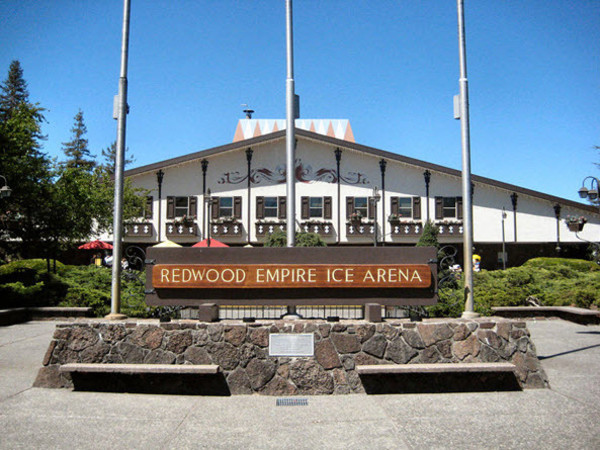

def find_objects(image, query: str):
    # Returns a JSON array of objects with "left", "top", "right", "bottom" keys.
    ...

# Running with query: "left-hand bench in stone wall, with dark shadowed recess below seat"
[{"left": 58, "top": 363, "right": 226, "bottom": 395}]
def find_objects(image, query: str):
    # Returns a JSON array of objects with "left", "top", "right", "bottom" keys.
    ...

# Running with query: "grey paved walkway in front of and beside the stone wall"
[{"left": 0, "top": 320, "right": 600, "bottom": 449}]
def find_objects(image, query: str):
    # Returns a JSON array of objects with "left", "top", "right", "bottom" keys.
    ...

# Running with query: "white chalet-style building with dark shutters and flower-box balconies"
[{"left": 118, "top": 119, "right": 600, "bottom": 269}]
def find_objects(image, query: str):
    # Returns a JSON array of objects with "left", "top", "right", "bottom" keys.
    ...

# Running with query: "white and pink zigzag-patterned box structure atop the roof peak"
[{"left": 233, "top": 119, "right": 355, "bottom": 142}]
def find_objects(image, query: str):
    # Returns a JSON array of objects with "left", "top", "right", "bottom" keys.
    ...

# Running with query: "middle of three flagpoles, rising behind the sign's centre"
[{"left": 285, "top": 0, "right": 296, "bottom": 247}]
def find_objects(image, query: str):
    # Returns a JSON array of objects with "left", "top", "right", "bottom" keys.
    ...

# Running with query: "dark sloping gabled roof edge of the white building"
[{"left": 124, "top": 128, "right": 598, "bottom": 214}]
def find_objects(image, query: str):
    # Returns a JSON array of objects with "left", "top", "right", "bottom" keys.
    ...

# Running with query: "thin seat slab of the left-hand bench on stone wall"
[{"left": 59, "top": 363, "right": 221, "bottom": 375}]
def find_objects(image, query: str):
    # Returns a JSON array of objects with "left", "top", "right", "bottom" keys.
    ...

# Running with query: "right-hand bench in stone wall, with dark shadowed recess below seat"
[{"left": 356, "top": 362, "right": 522, "bottom": 394}]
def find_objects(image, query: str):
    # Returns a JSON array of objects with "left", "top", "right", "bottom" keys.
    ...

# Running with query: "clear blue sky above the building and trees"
[{"left": 0, "top": 0, "right": 600, "bottom": 199}]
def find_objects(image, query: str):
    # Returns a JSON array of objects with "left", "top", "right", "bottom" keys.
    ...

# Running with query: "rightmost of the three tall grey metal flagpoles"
[{"left": 457, "top": 0, "right": 479, "bottom": 319}]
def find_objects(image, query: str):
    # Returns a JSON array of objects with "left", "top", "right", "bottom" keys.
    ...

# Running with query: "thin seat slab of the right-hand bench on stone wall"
[{"left": 356, "top": 362, "right": 516, "bottom": 375}]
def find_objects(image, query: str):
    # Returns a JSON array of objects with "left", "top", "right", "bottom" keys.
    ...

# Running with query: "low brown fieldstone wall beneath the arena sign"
[{"left": 35, "top": 318, "right": 548, "bottom": 395}]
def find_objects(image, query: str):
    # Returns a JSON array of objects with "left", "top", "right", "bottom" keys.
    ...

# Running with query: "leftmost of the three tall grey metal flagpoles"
[{"left": 106, "top": 0, "right": 130, "bottom": 319}]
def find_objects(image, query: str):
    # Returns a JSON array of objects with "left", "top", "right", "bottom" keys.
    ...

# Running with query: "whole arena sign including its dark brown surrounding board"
[{"left": 146, "top": 247, "right": 437, "bottom": 306}]
